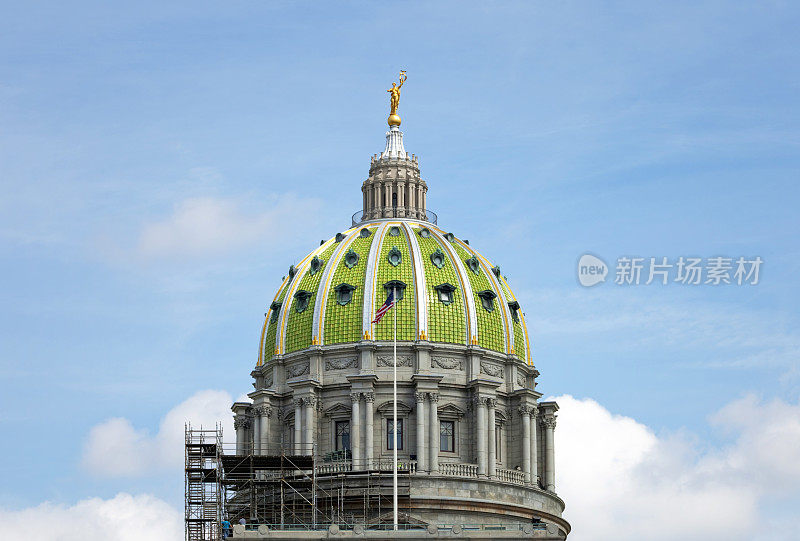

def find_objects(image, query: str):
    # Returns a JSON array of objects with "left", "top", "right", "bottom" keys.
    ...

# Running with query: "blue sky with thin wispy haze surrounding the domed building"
[{"left": 0, "top": 2, "right": 800, "bottom": 536}]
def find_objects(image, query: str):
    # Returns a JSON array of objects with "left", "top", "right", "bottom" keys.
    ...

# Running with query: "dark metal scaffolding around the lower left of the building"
[{"left": 186, "top": 424, "right": 421, "bottom": 541}]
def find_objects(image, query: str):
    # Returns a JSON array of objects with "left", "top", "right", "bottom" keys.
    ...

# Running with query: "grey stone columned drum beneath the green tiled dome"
[{"left": 233, "top": 340, "right": 569, "bottom": 538}]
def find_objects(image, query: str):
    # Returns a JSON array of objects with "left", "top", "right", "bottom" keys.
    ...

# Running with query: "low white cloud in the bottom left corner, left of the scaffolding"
[{"left": 0, "top": 493, "right": 183, "bottom": 541}]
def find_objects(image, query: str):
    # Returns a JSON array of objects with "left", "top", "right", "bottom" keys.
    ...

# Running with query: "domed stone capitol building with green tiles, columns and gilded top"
[{"left": 220, "top": 86, "right": 570, "bottom": 540}]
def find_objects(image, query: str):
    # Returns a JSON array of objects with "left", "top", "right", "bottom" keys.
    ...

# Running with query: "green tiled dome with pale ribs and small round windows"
[{"left": 258, "top": 219, "right": 532, "bottom": 365}]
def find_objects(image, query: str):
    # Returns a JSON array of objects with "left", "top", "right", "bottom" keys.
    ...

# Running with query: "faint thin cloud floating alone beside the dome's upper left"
[{"left": 136, "top": 194, "right": 321, "bottom": 259}]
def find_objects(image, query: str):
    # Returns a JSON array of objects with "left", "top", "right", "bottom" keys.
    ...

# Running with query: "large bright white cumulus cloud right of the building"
[{"left": 556, "top": 395, "right": 800, "bottom": 541}]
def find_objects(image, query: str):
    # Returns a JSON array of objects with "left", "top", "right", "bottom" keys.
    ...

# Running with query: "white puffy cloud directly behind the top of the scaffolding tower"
[{"left": 83, "top": 390, "right": 233, "bottom": 477}]
